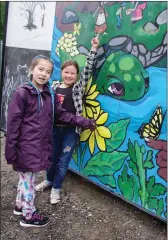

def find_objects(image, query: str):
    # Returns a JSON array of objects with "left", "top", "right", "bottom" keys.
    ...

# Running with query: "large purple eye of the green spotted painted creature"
[{"left": 108, "top": 78, "right": 125, "bottom": 97}]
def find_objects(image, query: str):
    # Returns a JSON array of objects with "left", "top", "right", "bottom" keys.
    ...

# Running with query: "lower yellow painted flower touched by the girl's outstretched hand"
[{"left": 80, "top": 106, "right": 111, "bottom": 154}]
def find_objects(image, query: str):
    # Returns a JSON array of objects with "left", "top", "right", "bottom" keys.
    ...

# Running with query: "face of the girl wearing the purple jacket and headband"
[{"left": 31, "top": 59, "right": 53, "bottom": 89}]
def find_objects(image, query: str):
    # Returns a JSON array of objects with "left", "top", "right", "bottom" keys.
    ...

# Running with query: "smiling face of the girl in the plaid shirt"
[{"left": 62, "top": 65, "right": 78, "bottom": 86}]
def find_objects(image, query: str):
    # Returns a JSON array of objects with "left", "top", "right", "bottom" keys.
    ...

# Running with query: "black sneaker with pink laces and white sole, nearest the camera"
[{"left": 20, "top": 212, "right": 50, "bottom": 227}]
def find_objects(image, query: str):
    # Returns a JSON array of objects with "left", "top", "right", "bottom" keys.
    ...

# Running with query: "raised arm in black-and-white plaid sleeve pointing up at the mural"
[{"left": 78, "top": 37, "right": 99, "bottom": 90}]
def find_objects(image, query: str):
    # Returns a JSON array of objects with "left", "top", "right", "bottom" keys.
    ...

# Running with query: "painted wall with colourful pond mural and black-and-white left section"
[{"left": 2, "top": 1, "right": 167, "bottom": 221}]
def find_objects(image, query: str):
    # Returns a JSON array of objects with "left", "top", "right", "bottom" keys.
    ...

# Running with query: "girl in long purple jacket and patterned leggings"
[{"left": 5, "top": 56, "right": 95, "bottom": 227}]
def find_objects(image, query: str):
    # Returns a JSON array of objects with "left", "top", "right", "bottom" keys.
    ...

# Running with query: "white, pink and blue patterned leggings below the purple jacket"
[{"left": 16, "top": 172, "right": 36, "bottom": 218}]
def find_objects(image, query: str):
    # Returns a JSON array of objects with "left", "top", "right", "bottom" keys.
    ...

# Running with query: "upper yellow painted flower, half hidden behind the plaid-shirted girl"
[{"left": 83, "top": 78, "right": 99, "bottom": 118}]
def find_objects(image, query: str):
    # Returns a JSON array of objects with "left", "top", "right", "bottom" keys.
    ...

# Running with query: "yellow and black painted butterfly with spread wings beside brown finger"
[{"left": 137, "top": 106, "right": 166, "bottom": 139}]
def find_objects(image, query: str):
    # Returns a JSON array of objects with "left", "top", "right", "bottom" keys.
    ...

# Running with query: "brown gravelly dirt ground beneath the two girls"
[{"left": 1, "top": 137, "right": 167, "bottom": 240}]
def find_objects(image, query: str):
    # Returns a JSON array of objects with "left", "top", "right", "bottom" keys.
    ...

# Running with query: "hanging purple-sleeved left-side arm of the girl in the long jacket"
[{"left": 5, "top": 89, "right": 25, "bottom": 164}]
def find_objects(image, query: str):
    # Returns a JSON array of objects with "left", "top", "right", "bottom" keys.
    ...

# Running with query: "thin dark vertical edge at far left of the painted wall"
[{"left": 0, "top": 1, "right": 9, "bottom": 132}]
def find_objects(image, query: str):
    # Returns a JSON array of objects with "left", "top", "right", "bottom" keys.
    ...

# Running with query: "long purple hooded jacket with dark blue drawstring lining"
[{"left": 5, "top": 84, "right": 93, "bottom": 172}]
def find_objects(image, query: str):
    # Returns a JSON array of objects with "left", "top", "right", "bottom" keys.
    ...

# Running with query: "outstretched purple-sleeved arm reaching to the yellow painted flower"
[{"left": 55, "top": 98, "right": 96, "bottom": 131}]
